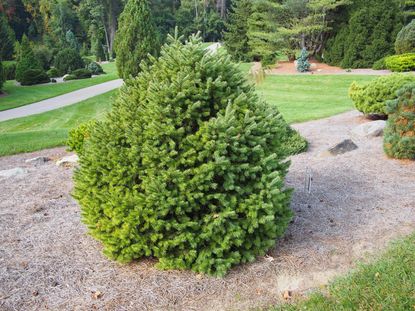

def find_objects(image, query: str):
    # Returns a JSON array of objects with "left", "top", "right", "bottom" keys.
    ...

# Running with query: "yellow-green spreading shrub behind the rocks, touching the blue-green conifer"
[{"left": 349, "top": 74, "right": 415, "bottom": 115}]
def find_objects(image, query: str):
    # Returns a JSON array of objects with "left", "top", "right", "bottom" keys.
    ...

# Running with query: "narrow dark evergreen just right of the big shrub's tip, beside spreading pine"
[{"left": 224, "top": 0, "right": 252, "bottom": 61}]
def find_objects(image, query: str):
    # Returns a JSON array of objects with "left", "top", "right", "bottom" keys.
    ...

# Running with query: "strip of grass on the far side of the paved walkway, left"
[{"left": 0, "top": 63, "right": 118, "bottom": 111}]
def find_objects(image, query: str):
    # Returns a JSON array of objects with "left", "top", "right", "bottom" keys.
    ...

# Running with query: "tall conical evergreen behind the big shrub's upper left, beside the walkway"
[{"left": 115, "top": 0, "right": 159, "bottom": 79}]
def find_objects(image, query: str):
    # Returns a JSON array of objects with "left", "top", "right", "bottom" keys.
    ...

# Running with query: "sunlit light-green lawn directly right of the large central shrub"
[{"left": 257, "top": 75, "right": 376, "bottom": 123}]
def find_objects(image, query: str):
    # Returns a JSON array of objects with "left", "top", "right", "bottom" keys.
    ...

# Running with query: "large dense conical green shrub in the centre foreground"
[{"left": 74, "top": 37, "right": 292, "bottom": 275}]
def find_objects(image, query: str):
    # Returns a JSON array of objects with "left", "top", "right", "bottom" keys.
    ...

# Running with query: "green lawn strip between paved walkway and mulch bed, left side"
[{"left": 0, "top": 90, "right": 118, "bottom": 156}]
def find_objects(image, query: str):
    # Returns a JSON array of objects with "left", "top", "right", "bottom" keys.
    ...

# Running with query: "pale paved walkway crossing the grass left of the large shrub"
[{"left": 0, "top": 79, "right": 124, "bottom": 122}]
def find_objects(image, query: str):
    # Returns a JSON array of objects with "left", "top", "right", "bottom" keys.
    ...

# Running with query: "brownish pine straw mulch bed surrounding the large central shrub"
[{"left": 0, "top": 112, "right": 415, "bottom": 310}]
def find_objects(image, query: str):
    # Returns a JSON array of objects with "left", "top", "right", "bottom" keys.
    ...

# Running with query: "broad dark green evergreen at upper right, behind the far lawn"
[{"left": 324, "top": 0, "right": 402, "bottom": 68}]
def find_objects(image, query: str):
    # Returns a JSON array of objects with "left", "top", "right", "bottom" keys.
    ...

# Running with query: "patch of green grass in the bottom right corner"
[{"left": 270, "top": 234, "right": 415, "bottom": 311}]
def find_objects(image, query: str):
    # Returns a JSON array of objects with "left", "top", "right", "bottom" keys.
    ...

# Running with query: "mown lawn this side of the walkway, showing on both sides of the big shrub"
[{"left": 0, "top": 74, "right": 374, "bottom": 156}]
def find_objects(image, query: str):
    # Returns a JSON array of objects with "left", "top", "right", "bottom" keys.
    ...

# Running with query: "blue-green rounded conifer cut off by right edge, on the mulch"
[{"left": 383, "top": 83, "right": 415, "bottom": 160}]
